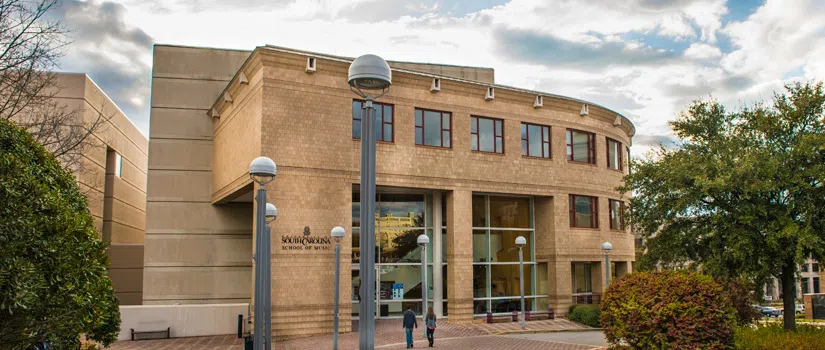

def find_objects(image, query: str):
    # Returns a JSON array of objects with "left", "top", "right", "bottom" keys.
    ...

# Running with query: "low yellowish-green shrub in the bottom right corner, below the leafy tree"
[{"left": 735, "top": 323, "right": 825, "bottom": 350}]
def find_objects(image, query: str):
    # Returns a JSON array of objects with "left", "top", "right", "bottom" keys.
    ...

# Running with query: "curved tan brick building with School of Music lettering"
[{"left": 143, "top": 45, "right": 635, "bottom": 338}]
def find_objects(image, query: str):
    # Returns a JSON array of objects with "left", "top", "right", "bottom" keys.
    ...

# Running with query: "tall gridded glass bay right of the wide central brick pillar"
[{"left": 472, "top": 195, "right": 547, "bottom": 315}]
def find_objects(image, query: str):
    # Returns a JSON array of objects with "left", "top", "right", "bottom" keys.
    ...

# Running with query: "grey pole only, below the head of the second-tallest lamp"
[{"left": 252, "top": 186, "right": 266, "bottom": 350}]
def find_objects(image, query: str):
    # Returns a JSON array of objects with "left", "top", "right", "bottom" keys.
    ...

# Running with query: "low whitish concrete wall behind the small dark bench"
[{"left": 117, "top": 303, "right": 249, "bottom": 340}]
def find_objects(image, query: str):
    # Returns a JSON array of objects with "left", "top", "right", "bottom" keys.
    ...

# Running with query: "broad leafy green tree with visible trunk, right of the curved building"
[{"left": 620, "top": 83, "right": 825, "bottom": 330}]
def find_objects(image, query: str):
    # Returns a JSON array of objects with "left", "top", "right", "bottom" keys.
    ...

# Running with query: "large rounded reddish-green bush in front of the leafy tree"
[{"left": 601, "top": 271, "right": 737, "bottom": 349}]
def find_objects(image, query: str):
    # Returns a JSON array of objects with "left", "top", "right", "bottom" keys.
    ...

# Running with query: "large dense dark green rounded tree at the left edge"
[{"left": 0, "top": 118, "right": 120, "bottom": 349}]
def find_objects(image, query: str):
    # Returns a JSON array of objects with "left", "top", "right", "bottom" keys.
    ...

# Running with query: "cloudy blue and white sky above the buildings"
[{"left": 53, "top": 0, "right": 825, "bottom": 155}]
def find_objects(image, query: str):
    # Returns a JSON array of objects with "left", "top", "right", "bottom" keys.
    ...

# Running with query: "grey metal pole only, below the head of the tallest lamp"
[{"left": 358, "top": 96, "right": 375, "bottom": 350}]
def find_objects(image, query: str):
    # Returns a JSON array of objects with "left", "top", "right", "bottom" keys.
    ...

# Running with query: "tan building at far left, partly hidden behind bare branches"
[{"left": 54, "top": 73, "right": 149, "bottom": 305}]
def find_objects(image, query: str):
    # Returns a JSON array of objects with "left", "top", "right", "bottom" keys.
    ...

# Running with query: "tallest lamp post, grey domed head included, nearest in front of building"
[{"left": 347, "top": 55, "right": 392, "bottom": 350}]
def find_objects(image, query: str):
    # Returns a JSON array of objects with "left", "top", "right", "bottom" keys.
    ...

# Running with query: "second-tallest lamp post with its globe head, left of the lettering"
[{"left": 249, "top": 157, "right": 277, "bottom": 350}]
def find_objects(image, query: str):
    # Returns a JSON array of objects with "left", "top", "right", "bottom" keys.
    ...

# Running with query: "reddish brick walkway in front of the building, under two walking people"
[{"left": 110, "top": 319, "right": 593, "bottom": 350}]
